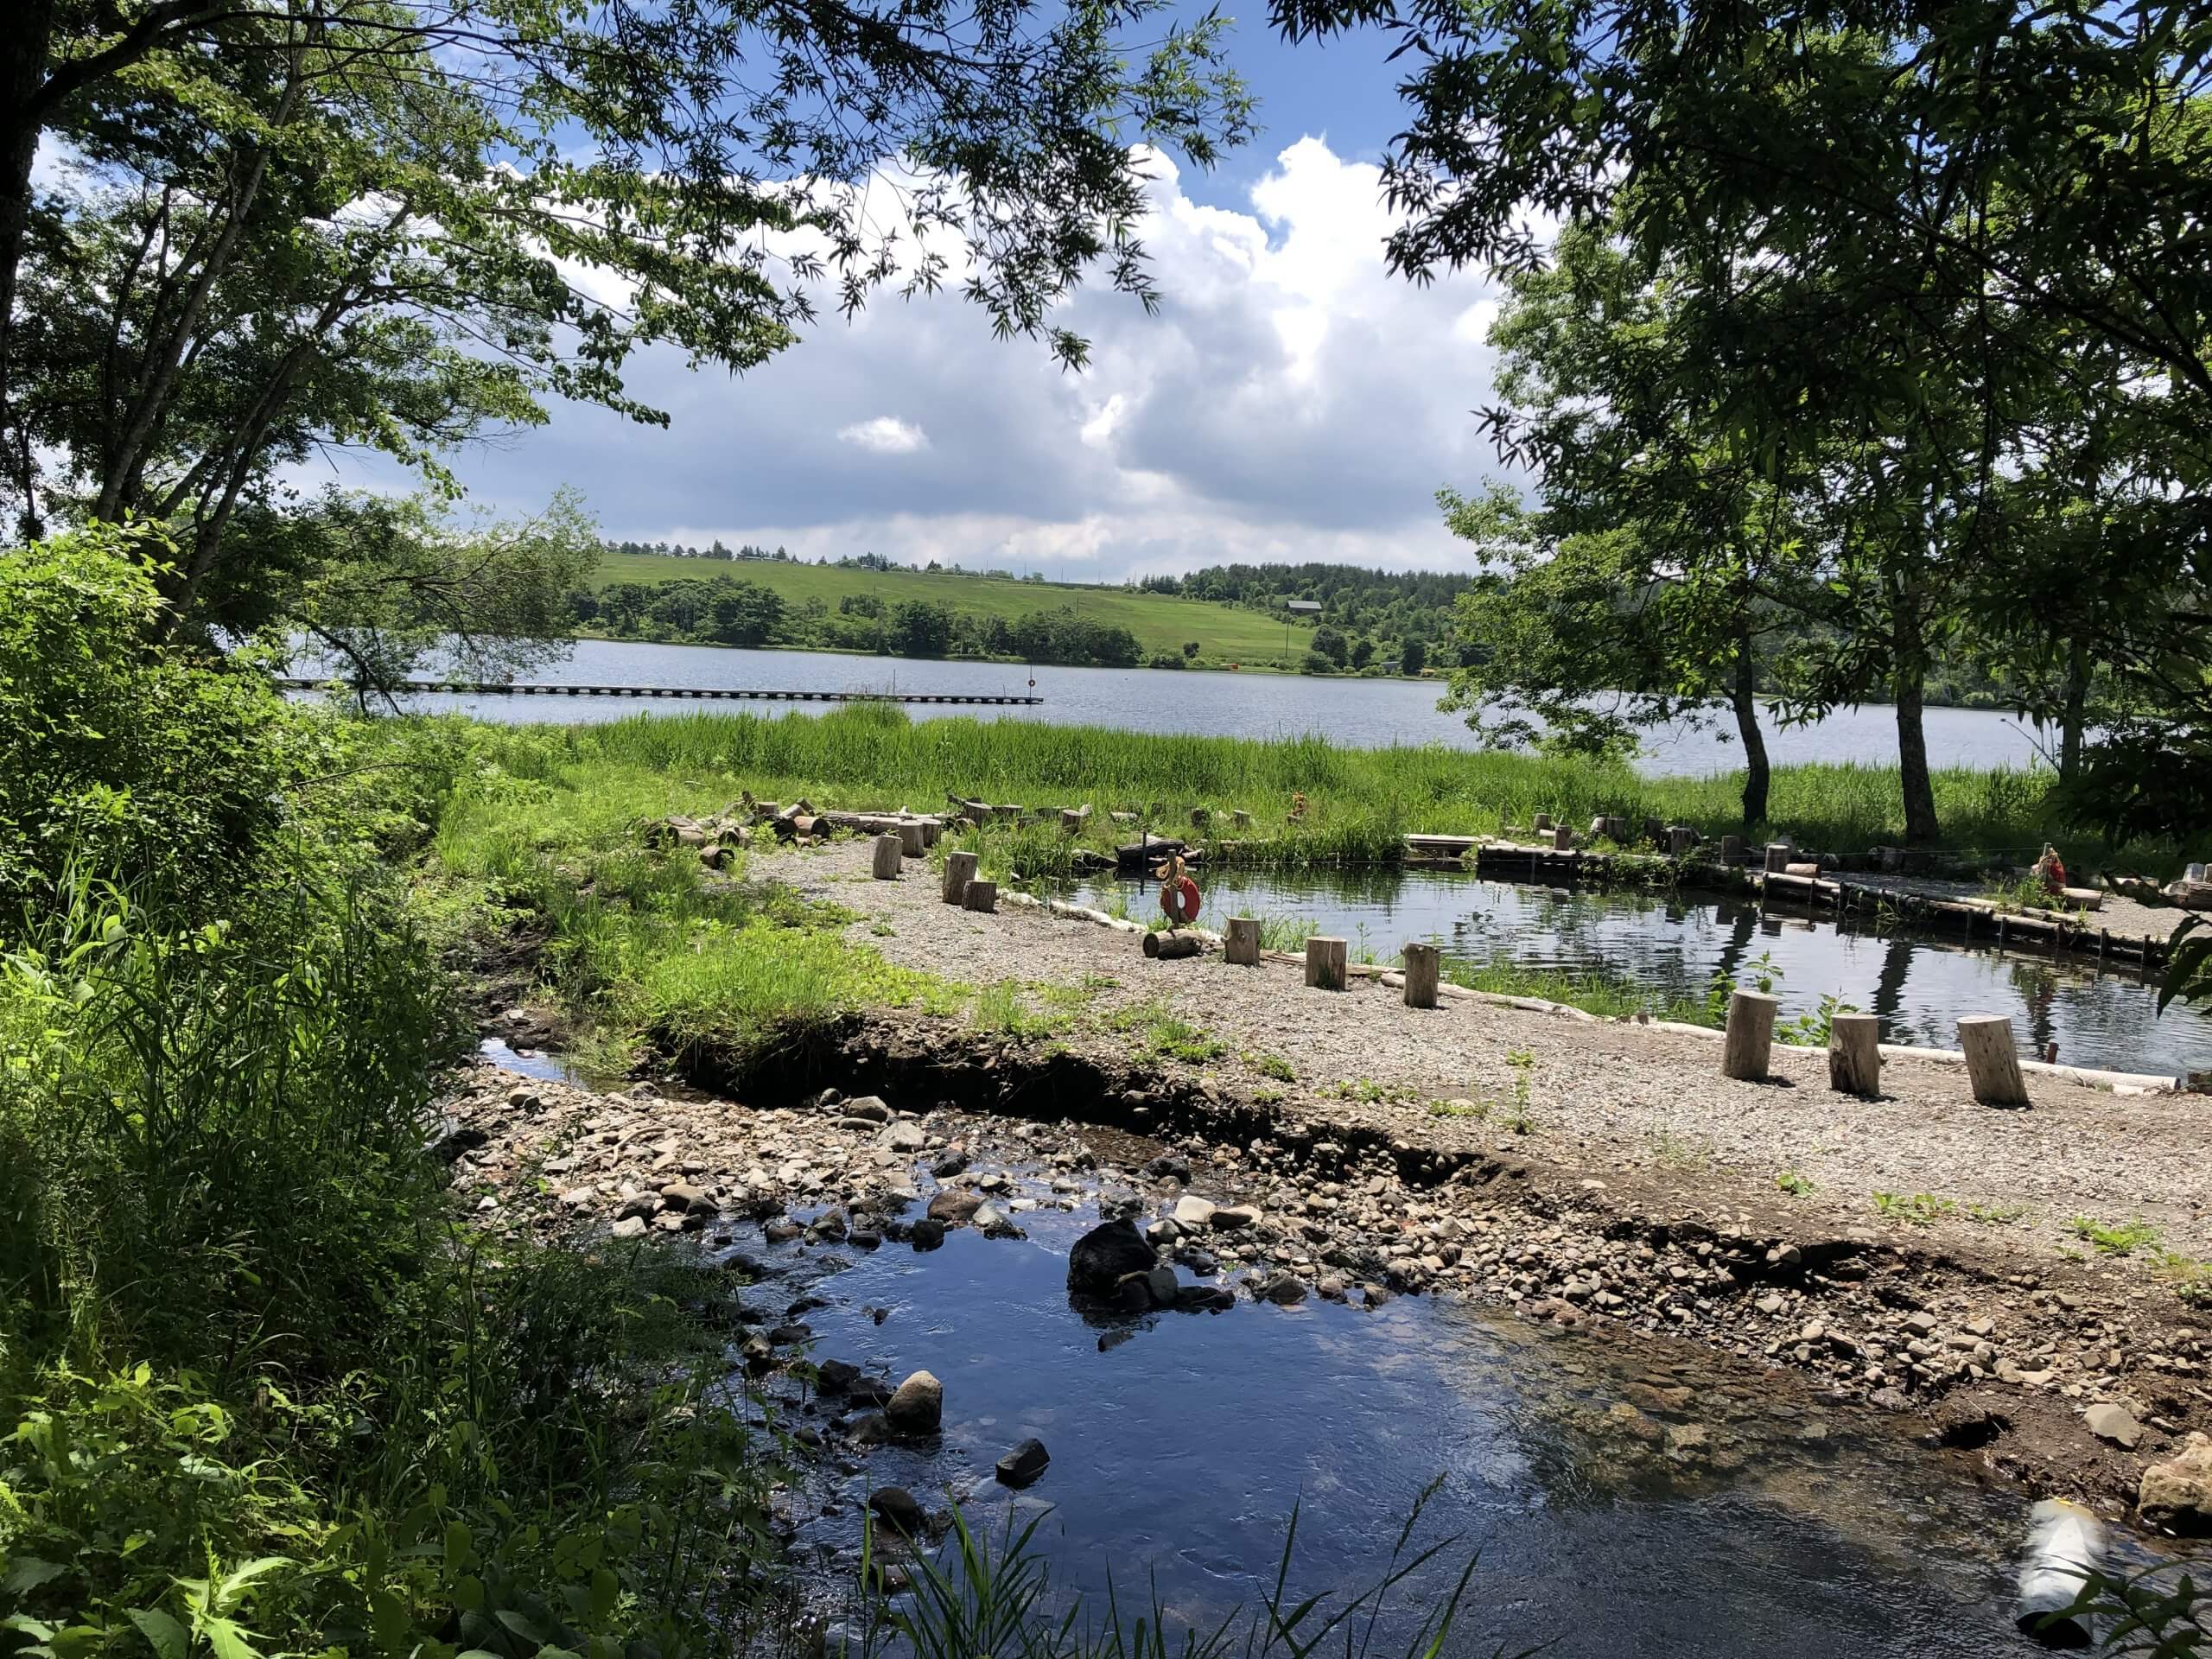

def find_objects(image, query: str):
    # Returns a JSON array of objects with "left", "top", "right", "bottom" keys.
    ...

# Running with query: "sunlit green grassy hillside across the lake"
[{"left": 593, "top": 553, "right": 1314, "bottom": 668}]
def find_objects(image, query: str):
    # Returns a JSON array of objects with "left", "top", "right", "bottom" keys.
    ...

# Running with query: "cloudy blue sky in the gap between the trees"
[{"left": 336, "top": 16, "right": 1497, "bottom": 582}]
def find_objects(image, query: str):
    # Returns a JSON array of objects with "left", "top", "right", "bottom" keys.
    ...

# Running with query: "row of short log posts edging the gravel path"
[{"left": 874, "top": 844, "right": 2029, "bottom": 1106}]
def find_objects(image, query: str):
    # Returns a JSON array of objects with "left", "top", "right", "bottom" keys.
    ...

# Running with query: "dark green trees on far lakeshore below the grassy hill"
[{"left": 569, "top": 575, "right": 1139, "bottom": 668}]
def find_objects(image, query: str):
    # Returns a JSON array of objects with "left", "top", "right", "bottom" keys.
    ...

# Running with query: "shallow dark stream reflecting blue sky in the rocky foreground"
[{"left": 712, "top": 1181, "right": 2194, "bottom": 1659}]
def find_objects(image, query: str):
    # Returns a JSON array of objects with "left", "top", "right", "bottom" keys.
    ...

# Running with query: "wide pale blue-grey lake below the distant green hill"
[{"left": 345, "top": 639, "right": 2037, "bottom": 777}]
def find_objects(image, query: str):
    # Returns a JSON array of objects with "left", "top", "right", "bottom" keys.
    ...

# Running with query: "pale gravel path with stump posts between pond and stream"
[{"left": 779, "top": 842, "right": 2212, "bottom": 1256}]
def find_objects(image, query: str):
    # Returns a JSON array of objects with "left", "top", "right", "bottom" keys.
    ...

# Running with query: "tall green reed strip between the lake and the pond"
[{"left": 448, "top": 706, "right": 2165, "bottom": 874}]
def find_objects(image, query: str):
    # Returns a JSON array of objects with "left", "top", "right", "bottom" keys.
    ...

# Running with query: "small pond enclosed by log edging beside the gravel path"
[{"left": 1082, "top": 869, "right": 2212, "bottom": 1075}]
